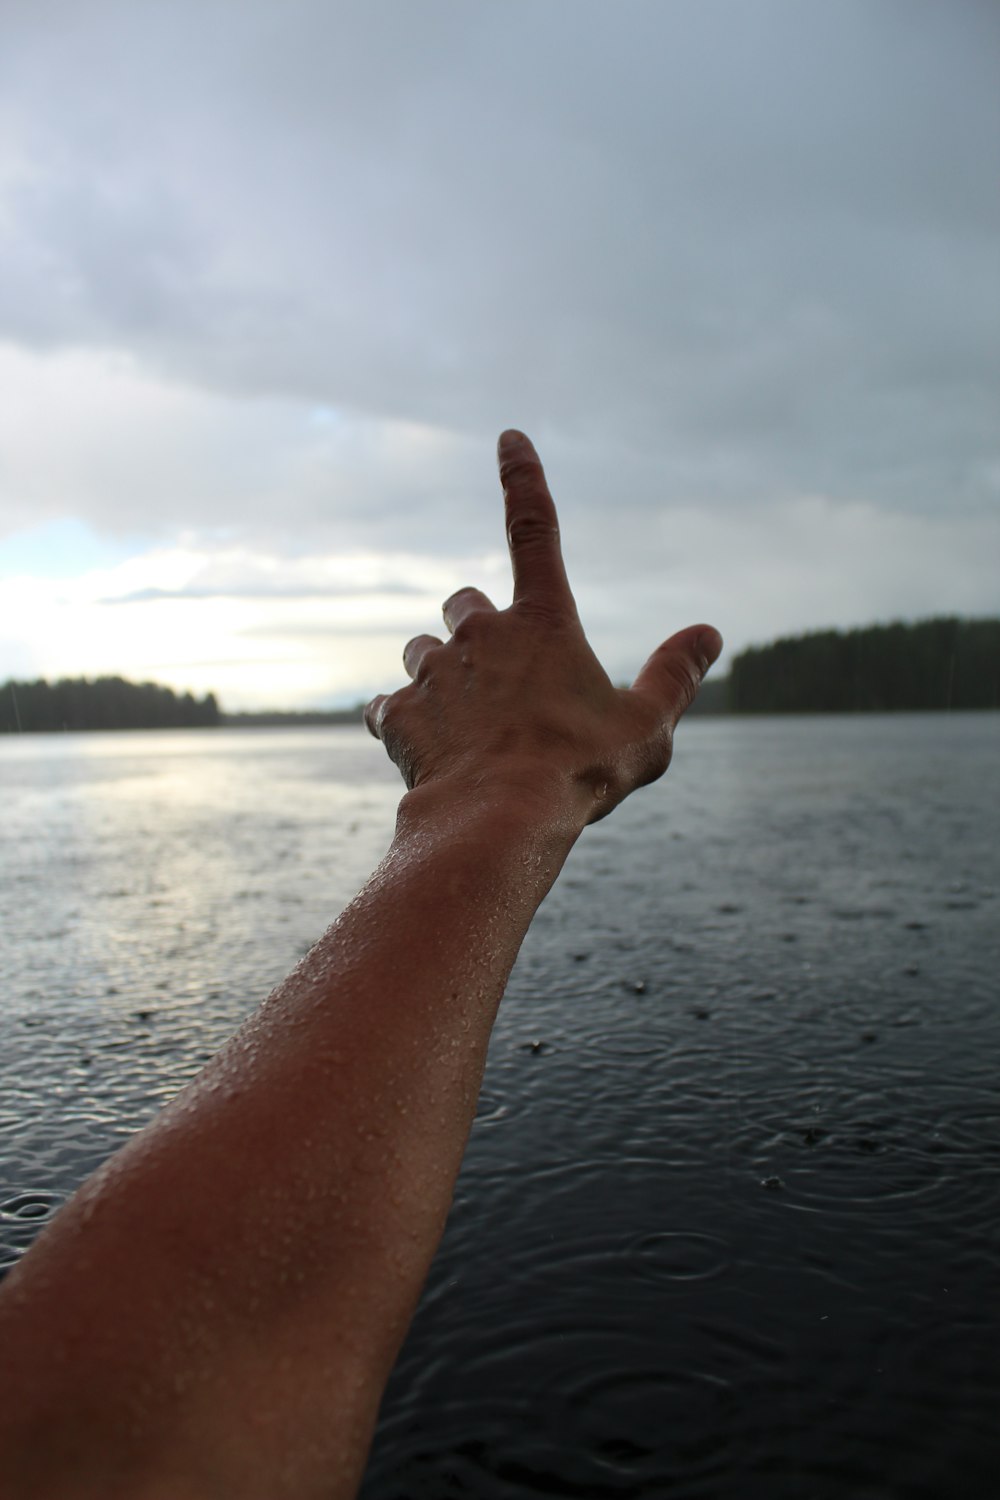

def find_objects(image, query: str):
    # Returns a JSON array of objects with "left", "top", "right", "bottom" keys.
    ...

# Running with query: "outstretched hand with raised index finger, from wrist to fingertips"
[{"left": 364, "top": 431, "right": 723, "bottom": 827}]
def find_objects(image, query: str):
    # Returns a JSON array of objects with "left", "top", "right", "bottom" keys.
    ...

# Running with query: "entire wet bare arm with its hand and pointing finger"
[{"left": 0, "top": 432, "right": 721, "bottom": 1500}]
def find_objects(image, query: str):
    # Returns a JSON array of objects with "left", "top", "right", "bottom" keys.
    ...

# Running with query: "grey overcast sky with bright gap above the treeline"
[{"left": 0, "top": 0, "right": 1000, "bottom": 708}]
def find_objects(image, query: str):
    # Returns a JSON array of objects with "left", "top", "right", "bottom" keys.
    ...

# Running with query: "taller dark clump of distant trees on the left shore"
[{"left": 0, "top": 677, "right": 220, "bottom": 735}]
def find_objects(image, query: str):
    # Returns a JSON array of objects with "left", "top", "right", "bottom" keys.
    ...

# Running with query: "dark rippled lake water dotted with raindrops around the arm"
[{"left": 0, "top": 714, "right": 1000, "bottom": 1500}]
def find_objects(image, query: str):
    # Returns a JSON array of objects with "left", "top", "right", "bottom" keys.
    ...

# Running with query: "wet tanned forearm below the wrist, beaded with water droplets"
[{"left": 0, "top": 788, "right": 585, "bottom": 1500}]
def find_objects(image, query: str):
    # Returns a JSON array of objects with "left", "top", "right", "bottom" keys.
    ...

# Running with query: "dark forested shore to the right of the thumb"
[{"left": 727, "top": 617, "right": 1000, "bottom": 714}]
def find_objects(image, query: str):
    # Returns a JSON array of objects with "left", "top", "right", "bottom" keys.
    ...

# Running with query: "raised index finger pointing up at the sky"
[{"left": 496, "top": 428, "right": 576, "bottom": 614}]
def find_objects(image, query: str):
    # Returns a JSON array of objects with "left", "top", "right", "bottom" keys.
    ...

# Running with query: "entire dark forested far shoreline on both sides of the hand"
[{"left": 0, "top": 615, "right": 1000, "bottom": 734}]
